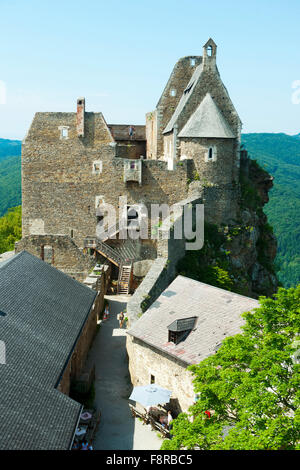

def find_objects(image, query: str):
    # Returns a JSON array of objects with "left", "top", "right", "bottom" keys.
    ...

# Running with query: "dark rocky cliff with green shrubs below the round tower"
[{"left": 177, "top": 157, "right": 278, "bottom": 297}]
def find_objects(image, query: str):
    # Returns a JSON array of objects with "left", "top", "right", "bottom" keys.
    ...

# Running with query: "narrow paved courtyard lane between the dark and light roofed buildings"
[{"left": 88, "top": 295, "right": 162, "bottom": 450}]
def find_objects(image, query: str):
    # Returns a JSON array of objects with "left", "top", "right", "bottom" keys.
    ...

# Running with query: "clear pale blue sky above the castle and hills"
[{"left": 0, "top": 0, "right": 300, "bottom": 138}]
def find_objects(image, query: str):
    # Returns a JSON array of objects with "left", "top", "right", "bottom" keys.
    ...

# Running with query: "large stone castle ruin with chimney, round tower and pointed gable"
[{"left": 16, "top": 39, "right": 276, "bottom": 302}]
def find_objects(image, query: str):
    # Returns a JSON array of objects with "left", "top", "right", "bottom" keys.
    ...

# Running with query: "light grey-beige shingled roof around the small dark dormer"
[{"left": 127, "top": 276, "right": 259, "bottom": 365}]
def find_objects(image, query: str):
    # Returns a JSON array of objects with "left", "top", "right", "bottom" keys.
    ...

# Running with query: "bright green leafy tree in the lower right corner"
[{"left": 162, "top": 285, "right": 300, "bottom": 450}]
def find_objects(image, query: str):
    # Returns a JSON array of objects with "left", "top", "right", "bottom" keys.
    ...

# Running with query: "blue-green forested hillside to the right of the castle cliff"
[{"left": 242, "top": 134, "right": 300, "bottom": 287}]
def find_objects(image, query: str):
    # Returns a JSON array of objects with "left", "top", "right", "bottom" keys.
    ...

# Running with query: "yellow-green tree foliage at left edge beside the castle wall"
[{"left": 0, "top": 206, "right": 22, "bottom": 253}]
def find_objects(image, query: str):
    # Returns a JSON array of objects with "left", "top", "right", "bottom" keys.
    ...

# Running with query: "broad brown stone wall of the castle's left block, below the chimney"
[{"left": 22, "top": 113, "right": 189, "bottom": 248}]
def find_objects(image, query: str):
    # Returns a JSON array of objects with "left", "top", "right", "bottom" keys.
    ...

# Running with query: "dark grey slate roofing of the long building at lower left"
[{"left": 0, "top": 251, "right": 97, "bottom": 450}]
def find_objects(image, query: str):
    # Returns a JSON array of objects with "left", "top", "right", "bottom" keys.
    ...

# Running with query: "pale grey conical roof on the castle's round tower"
[{"left": 178, "top": 93, "right": 235, "bottom": 139}]
